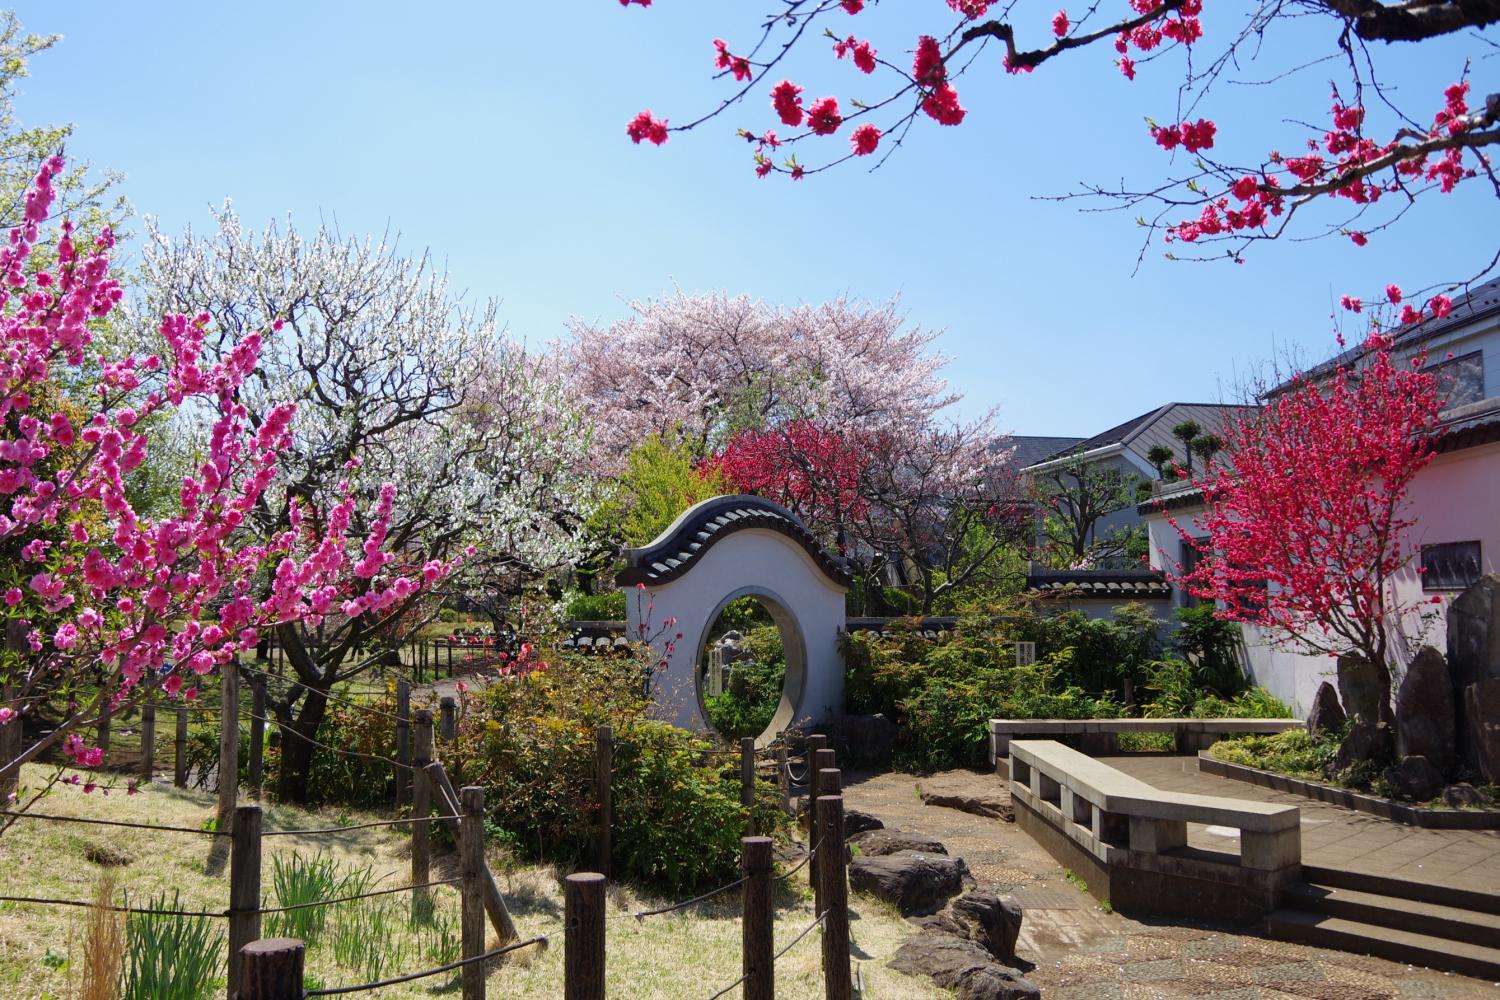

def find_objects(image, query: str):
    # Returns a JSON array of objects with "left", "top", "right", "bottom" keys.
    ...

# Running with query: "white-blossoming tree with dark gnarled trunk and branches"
[{"left": 133, "top": 205, "right": 588, "bottom": 801}]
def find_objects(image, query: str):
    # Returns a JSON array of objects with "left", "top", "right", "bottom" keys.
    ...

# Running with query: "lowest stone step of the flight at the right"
[{"left": 1266, "top": 909, "right": 1500, "bottom": 982}]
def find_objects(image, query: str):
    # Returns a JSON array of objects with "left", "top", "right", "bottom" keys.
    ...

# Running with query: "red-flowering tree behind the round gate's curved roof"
[{"left": 713, "top": 420, "right": 870, "bottom": 549}]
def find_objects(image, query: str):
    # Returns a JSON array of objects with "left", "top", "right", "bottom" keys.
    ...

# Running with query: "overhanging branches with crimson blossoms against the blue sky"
[{"left": 621, "top": 0, "right": 1500, "bottom": 299}]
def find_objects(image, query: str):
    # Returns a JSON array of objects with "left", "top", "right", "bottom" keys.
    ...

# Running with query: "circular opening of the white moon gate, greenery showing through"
[{"left": 698, "top": 594, "right": 806, "bottom": 747}]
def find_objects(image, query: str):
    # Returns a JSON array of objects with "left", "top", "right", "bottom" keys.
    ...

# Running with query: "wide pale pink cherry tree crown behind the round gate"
[{"left": 558, "top": 292, "right": 956, "bottom": 474}]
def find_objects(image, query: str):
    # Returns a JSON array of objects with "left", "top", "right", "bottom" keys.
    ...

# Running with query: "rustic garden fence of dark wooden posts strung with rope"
[{"left": 0, "top": 672, "right": 854, "bottom": 1000}]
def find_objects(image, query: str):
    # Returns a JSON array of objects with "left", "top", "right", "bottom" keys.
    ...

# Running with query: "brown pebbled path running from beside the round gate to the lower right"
[{"left": 845, "top": 773, "right": 1500, "bottom": 1000}]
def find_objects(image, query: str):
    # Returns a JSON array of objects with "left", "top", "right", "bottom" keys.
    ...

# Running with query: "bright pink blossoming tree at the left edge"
[{"left": 0, "top": 157, "right": 438, "bottom": 829}]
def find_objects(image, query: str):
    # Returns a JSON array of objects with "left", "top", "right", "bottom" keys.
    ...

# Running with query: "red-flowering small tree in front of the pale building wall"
[{"left": 1173, "top": 336, "right": 1443, "bottom": 717}]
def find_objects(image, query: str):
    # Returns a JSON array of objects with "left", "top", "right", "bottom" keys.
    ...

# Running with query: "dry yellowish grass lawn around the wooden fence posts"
[{"left": 0, "top": 769, "right": 950, "bottom": 1000}]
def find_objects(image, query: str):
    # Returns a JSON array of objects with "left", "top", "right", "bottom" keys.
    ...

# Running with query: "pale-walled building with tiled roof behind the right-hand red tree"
[{"left": 1137, "top": 279, "right": 1500, "bottom": 715}]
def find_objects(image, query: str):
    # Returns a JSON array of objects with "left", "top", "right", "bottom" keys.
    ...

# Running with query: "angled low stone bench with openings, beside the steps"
[{"left": 1010, "top": 739, "right": 1302, "bottom": 921}]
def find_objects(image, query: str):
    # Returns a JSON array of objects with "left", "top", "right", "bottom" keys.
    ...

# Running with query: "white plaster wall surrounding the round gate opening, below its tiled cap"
[{"left": 626, "top": 528, "right": 845, "bottom": 732}]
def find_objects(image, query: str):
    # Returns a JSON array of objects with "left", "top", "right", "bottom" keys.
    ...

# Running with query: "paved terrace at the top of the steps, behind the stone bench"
[{"left": 1101, "top": 756, "right": 1500, "bottom": 892}]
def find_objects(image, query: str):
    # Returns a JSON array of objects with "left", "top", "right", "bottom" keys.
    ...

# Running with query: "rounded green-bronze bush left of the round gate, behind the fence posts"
[{"left": 444, "top": 654, "right": 786, "bottom": 892}]
